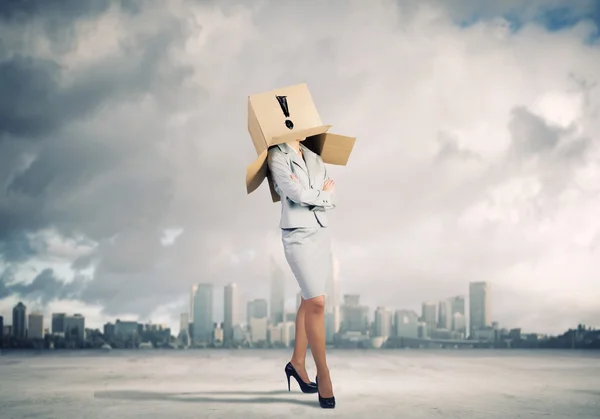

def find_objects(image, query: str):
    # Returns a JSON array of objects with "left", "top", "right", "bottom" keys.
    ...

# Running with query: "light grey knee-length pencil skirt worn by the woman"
[{"left": 281, "top": 227, "right": 333, "bottom": 300}]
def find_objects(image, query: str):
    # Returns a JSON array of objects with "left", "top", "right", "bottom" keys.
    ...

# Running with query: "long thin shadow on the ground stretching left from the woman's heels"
[{"left": 94, "top": 390, "right": 319, "bottom": 407}]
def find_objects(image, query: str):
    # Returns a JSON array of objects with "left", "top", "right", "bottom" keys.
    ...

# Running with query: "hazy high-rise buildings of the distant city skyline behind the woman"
[{"left": 0, "top": 278, "right": 536, "bottom": 344}]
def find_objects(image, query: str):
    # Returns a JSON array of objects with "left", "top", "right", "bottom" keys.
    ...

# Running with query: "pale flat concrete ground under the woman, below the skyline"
[{"left": 0, "top": 350, "right": 600, "bottom": 419}]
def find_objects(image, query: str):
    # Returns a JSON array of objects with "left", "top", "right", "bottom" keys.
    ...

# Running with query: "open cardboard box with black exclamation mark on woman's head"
[{"left": 246, "top": 83, "right": 356, "bottom": 202}]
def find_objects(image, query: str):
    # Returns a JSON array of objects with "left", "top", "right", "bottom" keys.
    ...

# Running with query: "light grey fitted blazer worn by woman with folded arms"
[{"left": 267, "top": 143, "right": 335, "bottom": 228}]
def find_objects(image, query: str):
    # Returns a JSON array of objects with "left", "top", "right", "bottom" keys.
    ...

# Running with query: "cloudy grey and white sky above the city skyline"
[{"left": 0, "top": 0, "right": 600, "bottom": 333}]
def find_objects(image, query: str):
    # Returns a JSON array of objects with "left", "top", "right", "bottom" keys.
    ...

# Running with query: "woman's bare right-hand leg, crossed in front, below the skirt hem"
[{"left": 303, "top": 296, "right": 333, "bottom": 398}]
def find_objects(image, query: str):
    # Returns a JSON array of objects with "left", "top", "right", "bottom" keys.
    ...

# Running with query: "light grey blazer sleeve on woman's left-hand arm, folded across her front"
[{"left": 267, "top": 148, "right": 331, "bottom": 207}]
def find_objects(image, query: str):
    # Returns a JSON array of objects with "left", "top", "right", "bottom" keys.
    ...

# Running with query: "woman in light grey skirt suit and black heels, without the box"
[{"left": 268, "top": 140, "right": 335, "bottom": 409}]
